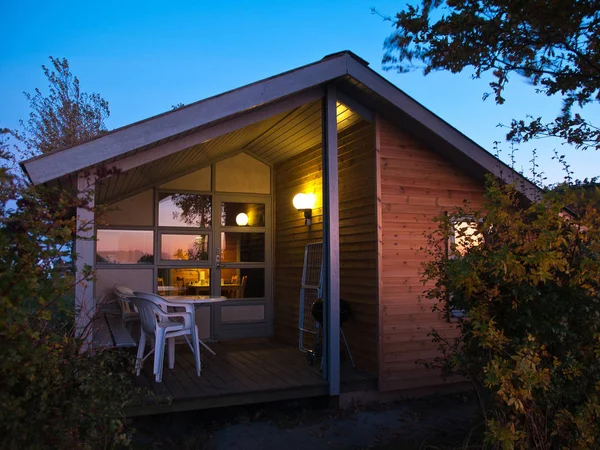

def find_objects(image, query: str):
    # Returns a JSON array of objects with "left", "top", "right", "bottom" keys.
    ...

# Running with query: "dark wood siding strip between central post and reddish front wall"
[{"left": 338, "top": 122, "right": 378, "bottom": 372}]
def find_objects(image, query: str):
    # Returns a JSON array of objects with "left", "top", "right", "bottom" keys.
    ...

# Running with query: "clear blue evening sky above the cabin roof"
[{"left": 0, "top": 0, "right": 600, "bottom": 182}]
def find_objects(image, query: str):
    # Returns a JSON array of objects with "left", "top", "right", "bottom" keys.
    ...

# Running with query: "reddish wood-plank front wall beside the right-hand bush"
[{"left": 378, "top": 120, "right": 484, "bottom": 391}]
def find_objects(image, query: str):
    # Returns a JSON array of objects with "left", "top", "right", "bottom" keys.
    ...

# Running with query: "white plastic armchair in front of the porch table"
[{"left": 130, "top": 292, "right": 201, "bottom": 383}]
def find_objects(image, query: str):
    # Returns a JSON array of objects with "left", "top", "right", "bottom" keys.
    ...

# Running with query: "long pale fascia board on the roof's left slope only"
[{"left": 22, "top": 54, "right": 347, "bottom": 185}]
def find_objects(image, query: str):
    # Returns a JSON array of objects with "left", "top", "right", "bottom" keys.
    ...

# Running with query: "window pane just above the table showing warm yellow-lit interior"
[{"left": 157, "top": 268, "right": 210, "bottom": 297}]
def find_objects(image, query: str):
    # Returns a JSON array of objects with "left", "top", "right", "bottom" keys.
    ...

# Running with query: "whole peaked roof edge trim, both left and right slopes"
[{"left": 20, "top": 50, "right": 542, "bottom": 200}]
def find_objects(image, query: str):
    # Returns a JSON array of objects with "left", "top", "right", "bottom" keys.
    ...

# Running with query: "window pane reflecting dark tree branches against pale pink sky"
[{"left": 158, "top": 193, "right": 212, "bottom": 228}]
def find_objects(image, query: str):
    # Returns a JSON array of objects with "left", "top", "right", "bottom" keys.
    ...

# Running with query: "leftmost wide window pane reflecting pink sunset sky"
[{"left": 96, "top": 230, "right": 154, "bottom": 264}]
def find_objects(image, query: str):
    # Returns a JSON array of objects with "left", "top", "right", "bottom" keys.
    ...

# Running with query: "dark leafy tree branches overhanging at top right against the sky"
[{"left": 383, "top": 0, "right": 600, "bottom": 149}]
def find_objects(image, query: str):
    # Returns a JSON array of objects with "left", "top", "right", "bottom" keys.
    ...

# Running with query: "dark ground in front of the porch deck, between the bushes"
[{"left": 133, "top": 395, "right": 478, "bottom": 450}]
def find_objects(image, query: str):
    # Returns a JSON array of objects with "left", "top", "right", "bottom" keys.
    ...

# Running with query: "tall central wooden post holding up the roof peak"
[{"left": 323, "top": 84, "right": 340, "bottom": 395}]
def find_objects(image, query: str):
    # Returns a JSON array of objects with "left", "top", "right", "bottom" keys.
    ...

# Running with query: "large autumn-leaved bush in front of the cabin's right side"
[{"left": 424, "top": 177, "right": 600, "bottom": 449}]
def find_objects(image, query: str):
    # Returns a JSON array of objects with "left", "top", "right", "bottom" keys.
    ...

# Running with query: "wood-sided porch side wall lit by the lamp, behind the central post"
[{"left": 274, "top": 121, "right": 378, "bottom": 371}]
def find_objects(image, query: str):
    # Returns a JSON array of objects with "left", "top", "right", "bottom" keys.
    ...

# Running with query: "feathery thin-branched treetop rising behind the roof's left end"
[{"left": 13, "top": 56, "right": 110, "bottom": 156}]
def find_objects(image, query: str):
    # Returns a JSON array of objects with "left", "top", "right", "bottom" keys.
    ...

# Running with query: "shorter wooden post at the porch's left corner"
[{"left": 75, "top": 172, "right": 96, "bottom": 350}]
